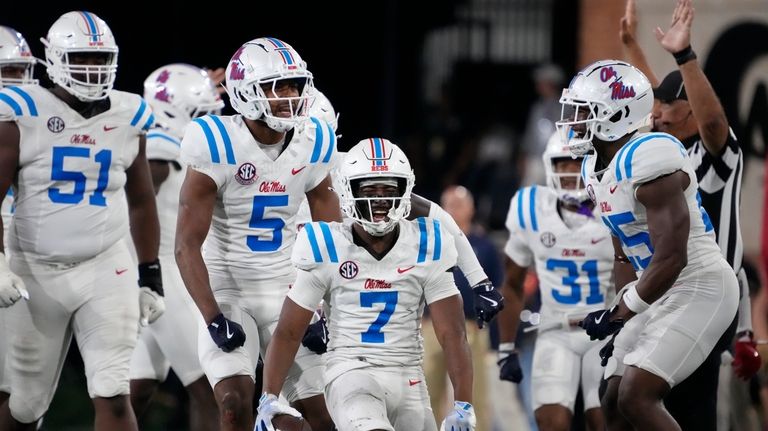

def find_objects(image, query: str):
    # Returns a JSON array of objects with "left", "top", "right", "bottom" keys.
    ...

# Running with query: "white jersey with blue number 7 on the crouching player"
[{"left": 288, "top": 218, "right": 456, "bottom": 372}]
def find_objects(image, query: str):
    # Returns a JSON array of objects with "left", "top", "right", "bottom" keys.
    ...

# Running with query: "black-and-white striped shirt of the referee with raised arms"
[{"left": 683, "top": 130, "right": 744, "bottom": 273}]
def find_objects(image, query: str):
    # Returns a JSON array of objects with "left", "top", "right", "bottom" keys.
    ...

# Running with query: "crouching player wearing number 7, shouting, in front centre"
[{"left": 256, "top": 138, "right": 475, "bottom": 431}]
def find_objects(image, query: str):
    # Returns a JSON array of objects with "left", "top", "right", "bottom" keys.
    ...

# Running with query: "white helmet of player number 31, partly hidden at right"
[{"left": 541, "top": 132, "right": 589, "bottom": 205}]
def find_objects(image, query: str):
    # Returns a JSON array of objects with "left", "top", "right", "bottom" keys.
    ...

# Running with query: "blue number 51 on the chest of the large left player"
[{"left": 48, "top": 147, "right": 112, "bottom": 207}]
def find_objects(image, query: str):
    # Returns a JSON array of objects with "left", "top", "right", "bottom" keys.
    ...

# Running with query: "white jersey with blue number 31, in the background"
[{"left": 504, "top": 186, "right": 613, "bottom": 316}]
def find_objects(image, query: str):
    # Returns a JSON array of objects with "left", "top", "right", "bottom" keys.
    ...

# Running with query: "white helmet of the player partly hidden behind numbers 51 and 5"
[{"left": 144, "top": 63, "right": 224, "bottom": 136}]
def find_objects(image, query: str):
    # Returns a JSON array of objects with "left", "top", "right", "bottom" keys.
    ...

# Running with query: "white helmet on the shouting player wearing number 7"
[{"left": 331, "top": 138, "right": 415, "bottom": 236}]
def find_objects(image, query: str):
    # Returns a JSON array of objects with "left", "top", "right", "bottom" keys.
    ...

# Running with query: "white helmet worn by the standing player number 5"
[{"left": 226, "top": 37, "right": 312, "bottom": 132}]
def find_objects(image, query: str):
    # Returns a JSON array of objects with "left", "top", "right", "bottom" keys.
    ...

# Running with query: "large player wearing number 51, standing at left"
[{"left": 0, "top": 11, "right": 164, "bottom": 430}]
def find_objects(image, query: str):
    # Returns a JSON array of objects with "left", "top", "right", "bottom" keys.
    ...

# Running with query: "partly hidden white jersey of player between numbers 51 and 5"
[{"left": 147, "top": 127, "right": 182, "bottom": 262}]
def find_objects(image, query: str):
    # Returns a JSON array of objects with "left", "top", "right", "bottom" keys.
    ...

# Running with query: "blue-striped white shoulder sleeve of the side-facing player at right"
[{"left": 615, "top": 133, "right": 688, "bottom": 190}]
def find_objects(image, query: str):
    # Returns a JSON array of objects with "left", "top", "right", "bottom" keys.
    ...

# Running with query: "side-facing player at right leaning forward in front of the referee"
[{"left": 558, "top": 60, "right": 739, "bottom": 430}]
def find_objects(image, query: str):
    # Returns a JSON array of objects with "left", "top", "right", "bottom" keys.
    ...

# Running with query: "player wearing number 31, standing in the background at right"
[{"left": 499, "top": 133, "right": 613, "bottom": 430}]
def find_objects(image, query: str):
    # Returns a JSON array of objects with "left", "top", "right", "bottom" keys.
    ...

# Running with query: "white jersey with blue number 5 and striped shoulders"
[{"left": 181, "top": 115, "right": 336, "bottom": 282}]
